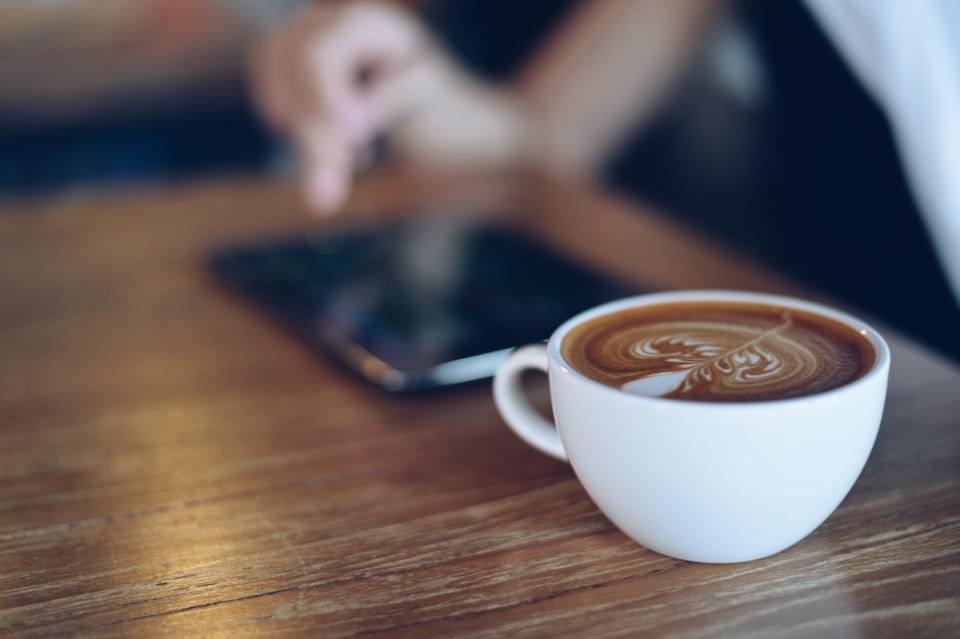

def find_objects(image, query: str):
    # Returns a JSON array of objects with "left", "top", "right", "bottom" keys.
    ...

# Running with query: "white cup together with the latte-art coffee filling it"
[{"left": 494, "top": 291, "right": 890, "bottom": 562}]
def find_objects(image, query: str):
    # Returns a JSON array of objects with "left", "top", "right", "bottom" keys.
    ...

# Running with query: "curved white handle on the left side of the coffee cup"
[{"left": 493, "top": 344, "right": 567, "bottom": 461}]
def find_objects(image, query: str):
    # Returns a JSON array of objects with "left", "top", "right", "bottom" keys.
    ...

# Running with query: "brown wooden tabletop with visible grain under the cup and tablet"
[{"left": 0, "top": 176, "right": 960, "bottom": 638}]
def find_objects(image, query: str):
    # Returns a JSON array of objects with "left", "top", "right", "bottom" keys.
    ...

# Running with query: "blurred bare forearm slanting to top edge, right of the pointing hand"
[{"left": 515, "top": 0, "right": 724, "bottom": 174}]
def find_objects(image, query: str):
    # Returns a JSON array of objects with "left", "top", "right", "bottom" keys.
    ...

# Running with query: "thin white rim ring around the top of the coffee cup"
[{"left": 547, "top": 289, "right": 890, "bottom": 410}]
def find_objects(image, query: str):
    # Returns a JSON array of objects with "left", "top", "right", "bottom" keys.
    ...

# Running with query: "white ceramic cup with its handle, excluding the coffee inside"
[{"left": 494, "top": 291, "right": 890, "bottom": 563}]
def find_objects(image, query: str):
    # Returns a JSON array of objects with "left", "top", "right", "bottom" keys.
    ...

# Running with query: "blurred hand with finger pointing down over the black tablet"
[{"left": 254, "top": 0, "right": 526, "bottom": 212}]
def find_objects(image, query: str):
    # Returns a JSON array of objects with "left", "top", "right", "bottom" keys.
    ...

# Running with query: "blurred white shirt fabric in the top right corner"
[{"left": 806, "top": 0, "right": 960, "bottom": 300}]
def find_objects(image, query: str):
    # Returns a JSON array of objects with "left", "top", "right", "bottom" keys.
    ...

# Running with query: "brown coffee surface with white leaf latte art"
[{"left": 560, "top": 302, "right": 876, "bottom": 402}]
